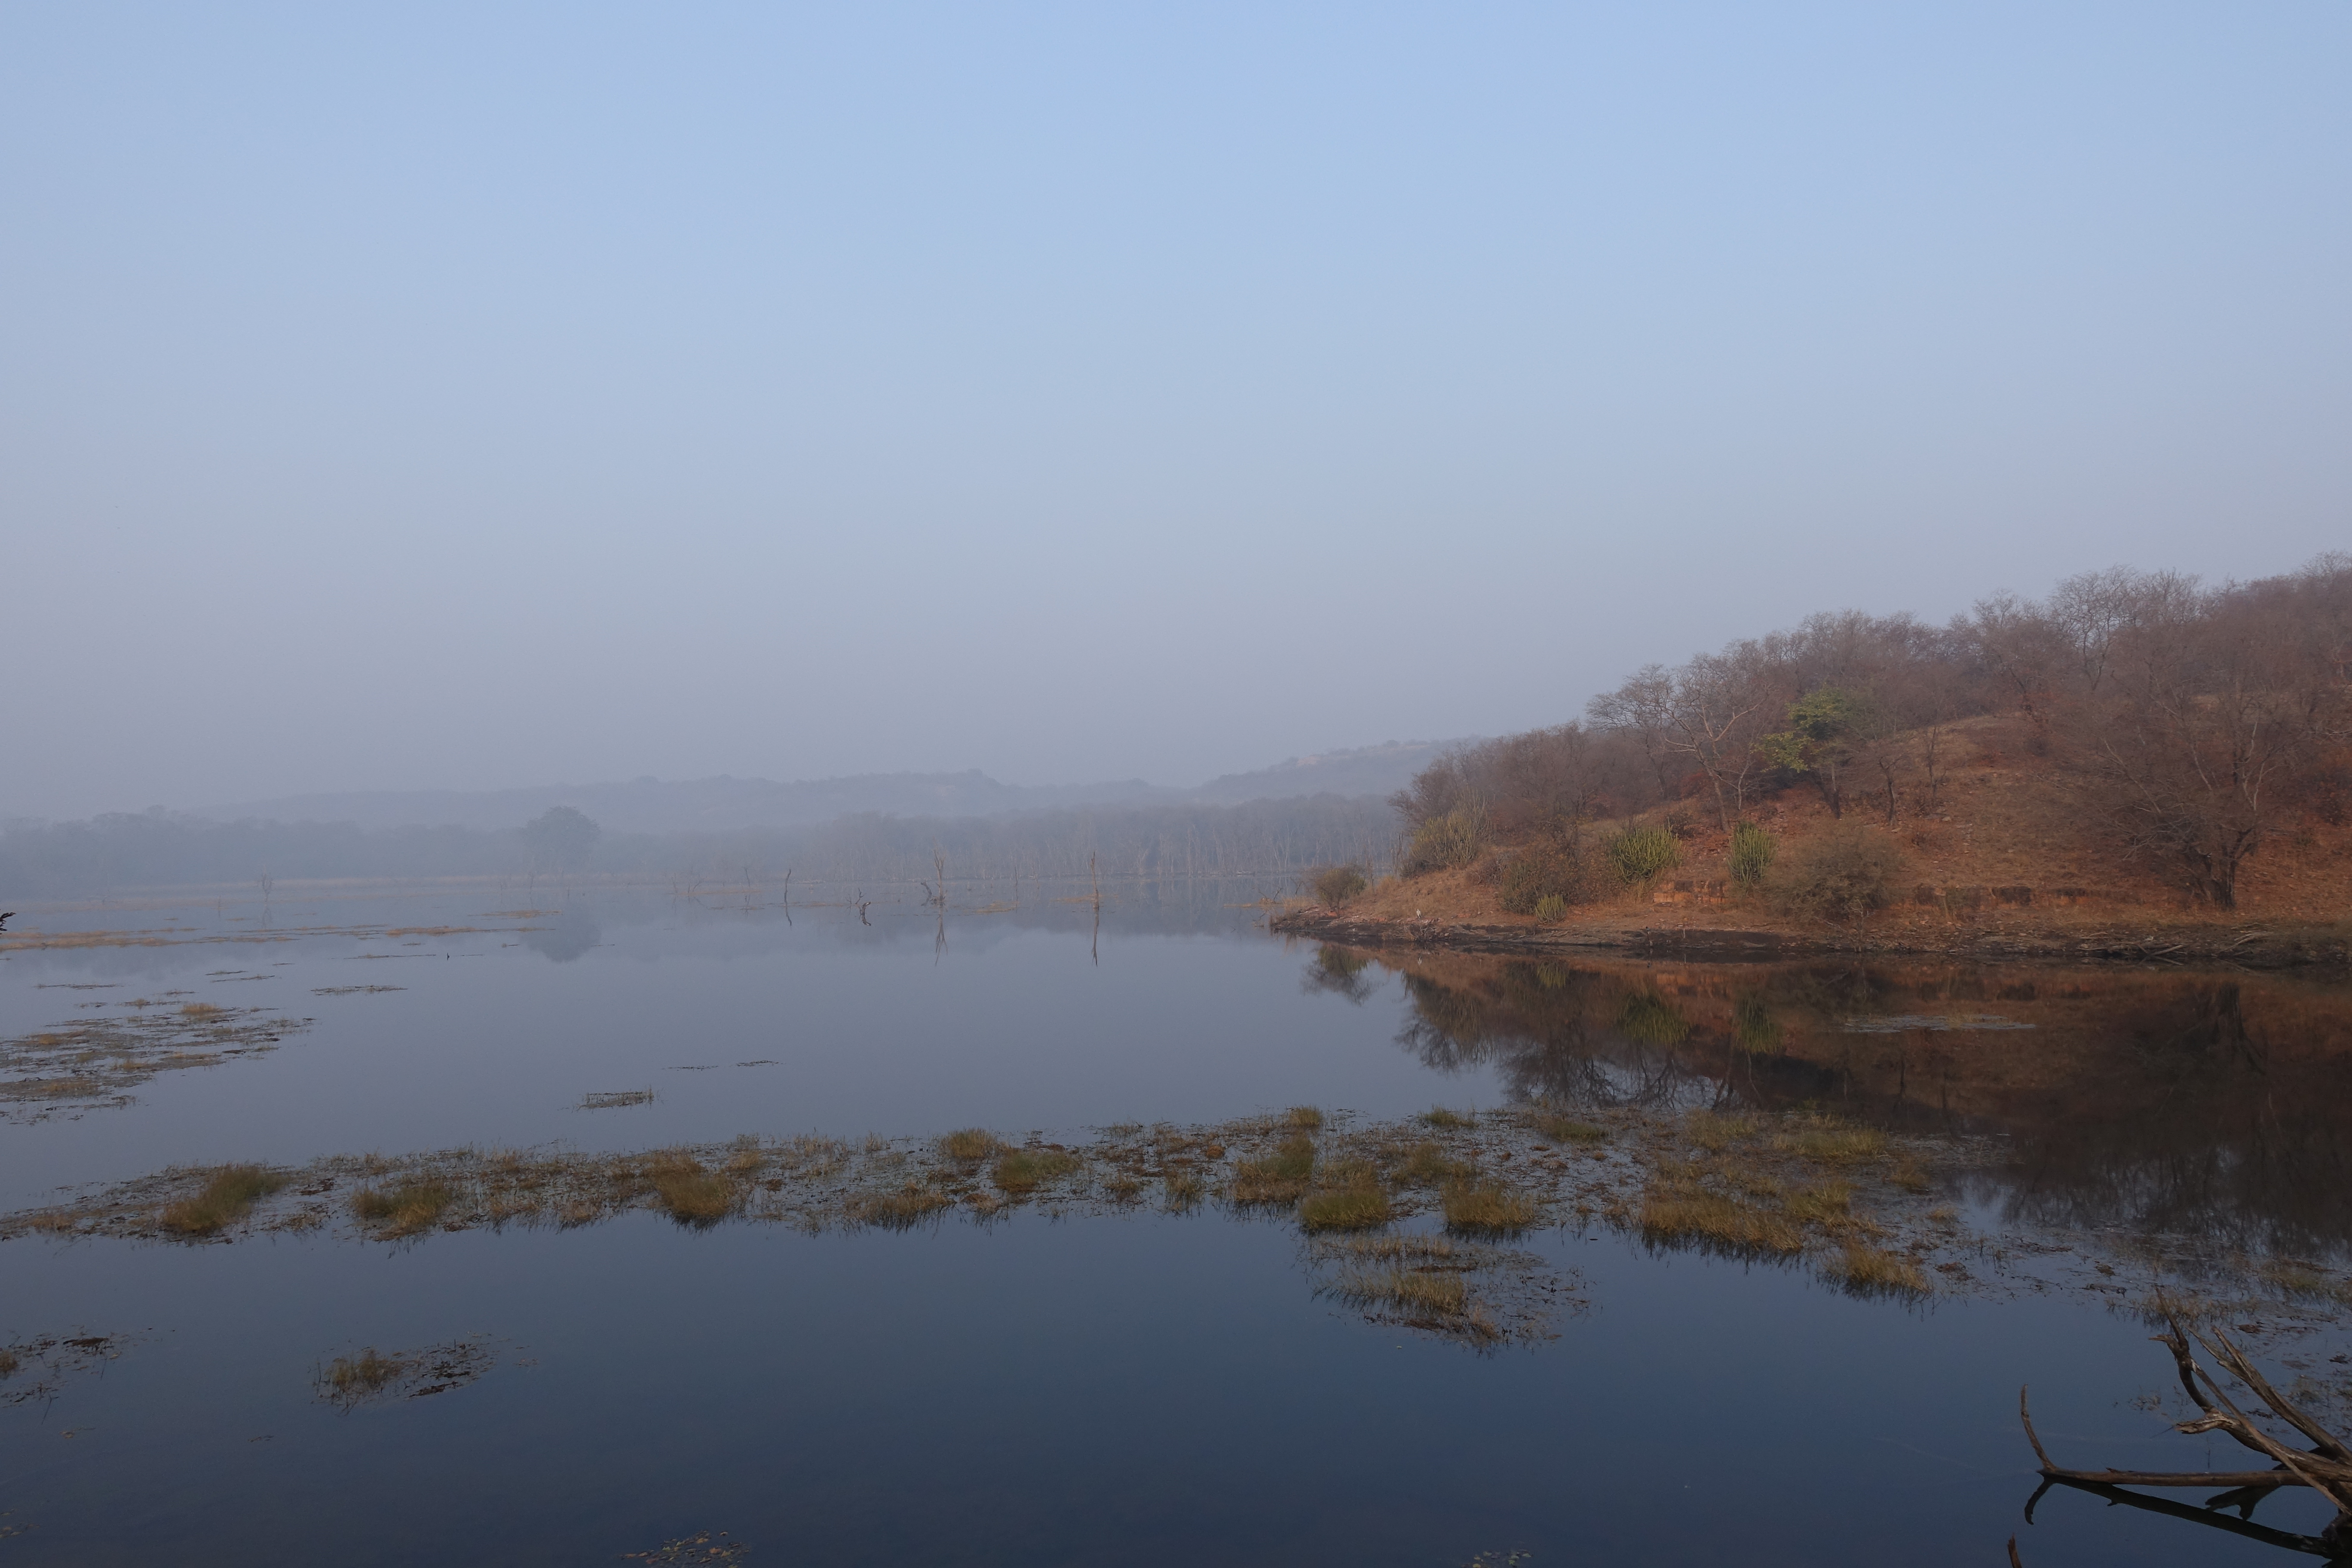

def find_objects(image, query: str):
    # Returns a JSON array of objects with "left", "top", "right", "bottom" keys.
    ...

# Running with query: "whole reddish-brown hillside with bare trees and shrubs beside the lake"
[{"left": 1284, "top": 560, "right": 2352, "bottom": 962}]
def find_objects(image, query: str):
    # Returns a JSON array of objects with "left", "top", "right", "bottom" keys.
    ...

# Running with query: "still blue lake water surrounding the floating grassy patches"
[{"left": 0, "top": 884, "right": 2352, "bottom": 1568}]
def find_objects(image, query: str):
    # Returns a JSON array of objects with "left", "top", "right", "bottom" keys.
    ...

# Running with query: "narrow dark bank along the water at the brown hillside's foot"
[{"left": 1268, "top": 907, "right": 2352, "bottom": 968}]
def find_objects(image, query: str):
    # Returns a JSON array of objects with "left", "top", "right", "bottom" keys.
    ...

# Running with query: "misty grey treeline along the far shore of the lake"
[{"left": 0, "top": 795, "right": 1397, "bottom": 898}]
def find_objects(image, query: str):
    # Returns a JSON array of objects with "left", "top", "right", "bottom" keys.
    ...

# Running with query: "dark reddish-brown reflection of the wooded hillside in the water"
[{"left": 1305, "top": 947, "right": 2352, "bottom": 1256}]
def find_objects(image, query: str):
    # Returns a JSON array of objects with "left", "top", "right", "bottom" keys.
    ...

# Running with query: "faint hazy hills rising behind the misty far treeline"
[{"left": 190, "top": 741, "right": 1451, "bottom": 832}]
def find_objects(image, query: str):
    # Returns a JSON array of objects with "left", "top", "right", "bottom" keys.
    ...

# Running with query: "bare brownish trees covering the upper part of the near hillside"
[{"left": 1395, "top": 555, "right": 2352, "bottom": 907}]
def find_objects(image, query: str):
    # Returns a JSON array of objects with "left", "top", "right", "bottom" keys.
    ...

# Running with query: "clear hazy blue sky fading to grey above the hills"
[{"left": 0, "top": 0, "right": 2352, "bottom": 816}]
